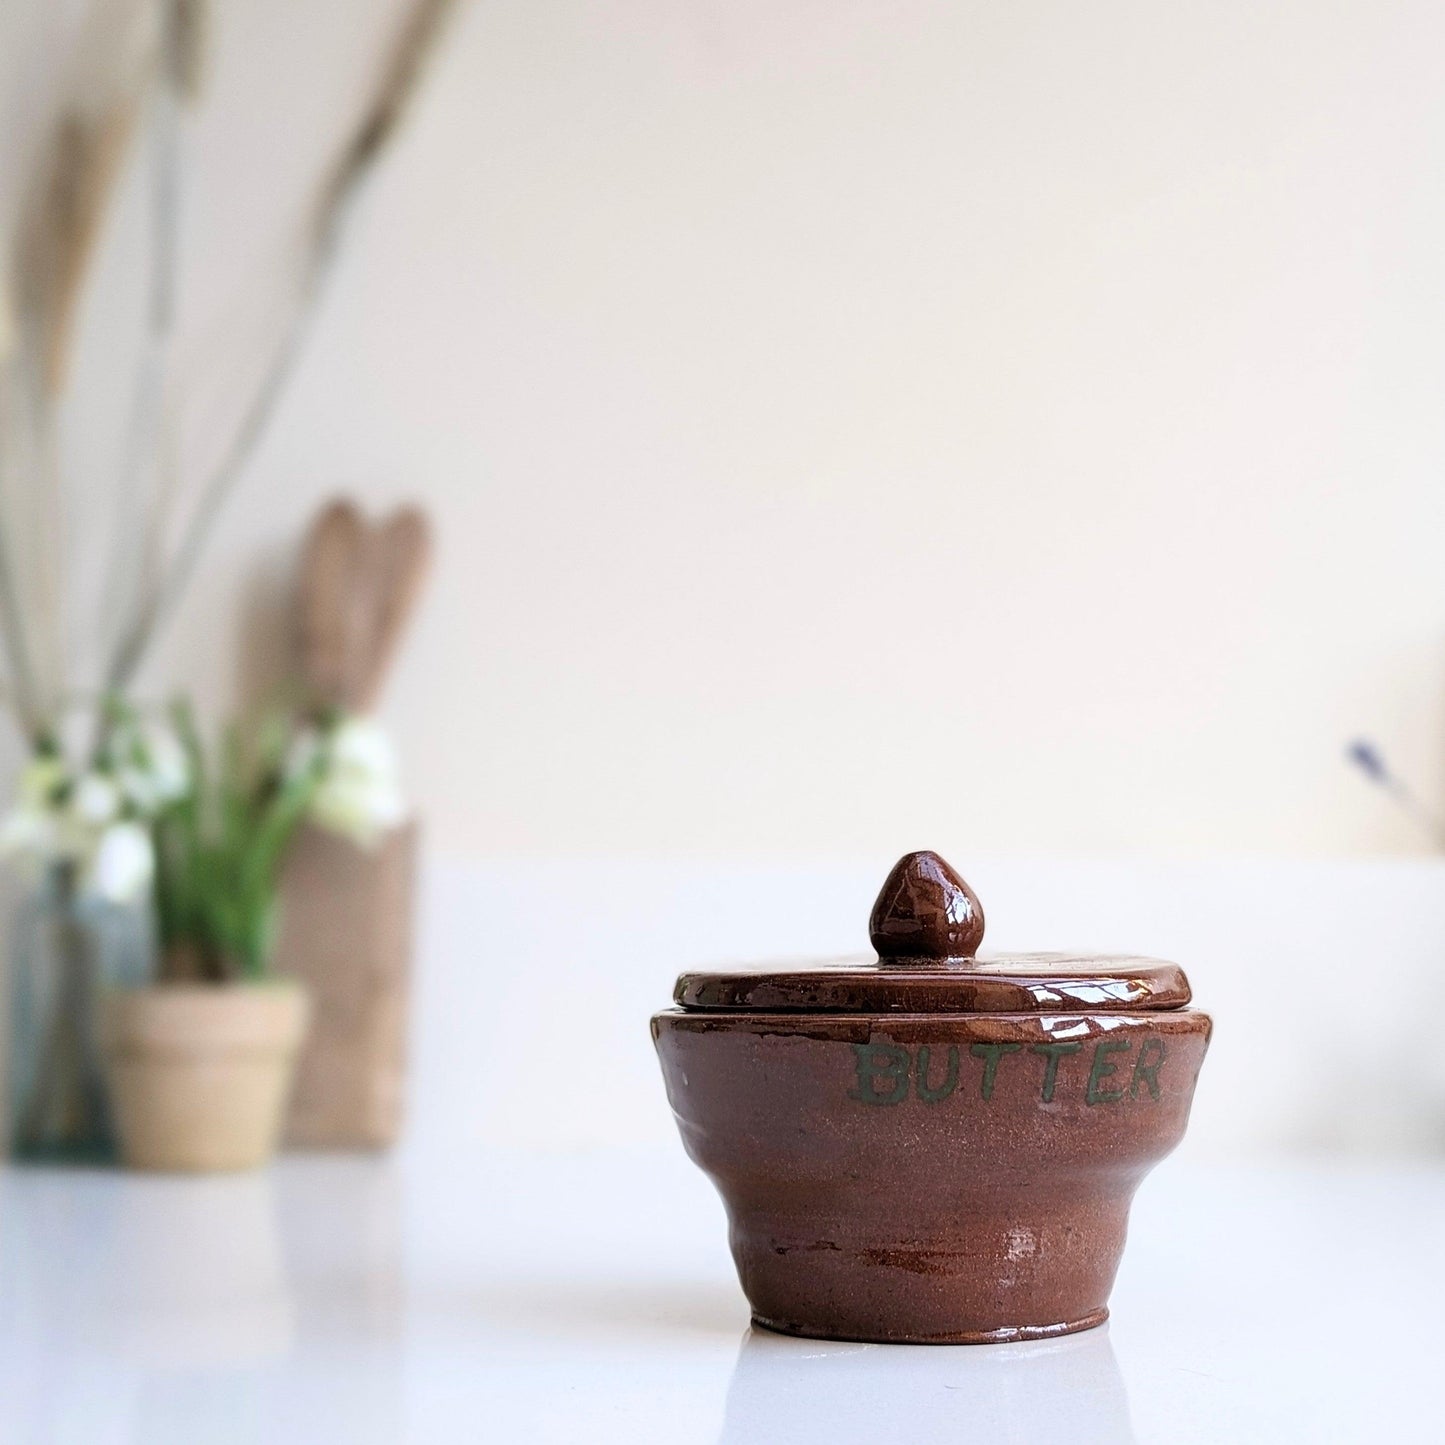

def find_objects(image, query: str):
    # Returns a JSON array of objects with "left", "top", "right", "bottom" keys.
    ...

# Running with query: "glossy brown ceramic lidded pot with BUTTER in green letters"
[{"left": 652, "top": 853, "right": 1211, "bottom": 1344}]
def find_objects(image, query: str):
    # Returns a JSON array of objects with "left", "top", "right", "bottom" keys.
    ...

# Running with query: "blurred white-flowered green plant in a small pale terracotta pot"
[{"left": 103, "top": 707, "right": 402, "bottom": 1172}]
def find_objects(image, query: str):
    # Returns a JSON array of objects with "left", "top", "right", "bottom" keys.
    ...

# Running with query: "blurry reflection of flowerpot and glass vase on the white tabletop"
[{"left": 0, "top": 1160, "right": 402, "bottom": 1445}]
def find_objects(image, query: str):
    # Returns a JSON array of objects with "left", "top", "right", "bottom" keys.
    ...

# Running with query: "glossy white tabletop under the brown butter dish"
[{"left": 0, "top": 1149, "right": 1445, "bottom": 1445}]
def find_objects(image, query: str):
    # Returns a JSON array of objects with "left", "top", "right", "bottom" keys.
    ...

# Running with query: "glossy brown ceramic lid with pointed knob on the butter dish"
[{"left": 673, "top": 853, "right": 1189, "bottom": 1013}]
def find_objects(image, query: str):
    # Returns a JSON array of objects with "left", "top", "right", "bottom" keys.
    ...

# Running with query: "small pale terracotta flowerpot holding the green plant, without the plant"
[{"left": 105, "top": 980, "right": 309, "bottom": 1173}]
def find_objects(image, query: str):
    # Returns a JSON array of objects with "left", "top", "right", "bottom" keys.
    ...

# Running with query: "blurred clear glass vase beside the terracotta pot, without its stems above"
[{"left": 7, "top": 864, "right": 153, "bottom": 1163}]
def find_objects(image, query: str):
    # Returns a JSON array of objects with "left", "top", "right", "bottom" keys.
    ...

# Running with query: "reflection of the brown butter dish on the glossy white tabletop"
[{"left": 718, "top": 1325, "right": 1134, "bottom": 1445}]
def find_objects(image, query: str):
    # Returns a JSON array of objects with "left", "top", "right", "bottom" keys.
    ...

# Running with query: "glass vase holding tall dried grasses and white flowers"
[{"left": 0, "top": 0, "right": 457, "bottom": 1160}]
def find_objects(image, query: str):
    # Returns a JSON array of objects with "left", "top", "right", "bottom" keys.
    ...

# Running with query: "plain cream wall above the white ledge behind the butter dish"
[{"left": 8, "top": 0, "right": 1445, "bottom": 855}]
